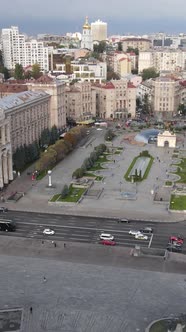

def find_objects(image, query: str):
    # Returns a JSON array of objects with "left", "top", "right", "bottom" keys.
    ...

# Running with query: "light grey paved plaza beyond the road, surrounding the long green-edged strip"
[{"left": 2, "top": 129, "right": 185, "bottom": 221}]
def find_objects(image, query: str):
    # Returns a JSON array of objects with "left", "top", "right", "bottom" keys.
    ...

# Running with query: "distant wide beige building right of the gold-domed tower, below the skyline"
[{"left": 122, "top": 38, "right": 151, "bottom": 52}]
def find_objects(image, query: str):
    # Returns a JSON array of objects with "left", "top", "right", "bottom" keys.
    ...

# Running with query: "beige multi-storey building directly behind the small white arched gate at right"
[{"left": 151, "top": 77, "right": 181, "bottom": 118}]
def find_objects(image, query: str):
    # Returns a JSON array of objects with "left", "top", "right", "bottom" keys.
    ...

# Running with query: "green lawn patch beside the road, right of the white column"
[{"left": 50, "top": 186, "right": 86, "bottom": 203}]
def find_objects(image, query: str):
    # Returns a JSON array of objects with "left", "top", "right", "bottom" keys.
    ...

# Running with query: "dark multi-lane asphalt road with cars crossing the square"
[{"left": 0, "top": 211, "right": 186, "bottom": 253}]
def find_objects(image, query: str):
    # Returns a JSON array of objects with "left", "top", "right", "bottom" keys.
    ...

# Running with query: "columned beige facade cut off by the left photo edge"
[{"left": 0, "top": 111, "right": 13, "bottom": 189}]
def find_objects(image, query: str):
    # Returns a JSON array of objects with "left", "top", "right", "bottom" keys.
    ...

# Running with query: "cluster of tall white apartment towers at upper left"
[{"left": 1, "top": 26, "right": 49, "bottom": 71}]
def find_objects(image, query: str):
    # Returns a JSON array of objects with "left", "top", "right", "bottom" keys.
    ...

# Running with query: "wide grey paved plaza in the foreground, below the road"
[{"left": 0, "top": 238, "right": 186, "bottom": 332}]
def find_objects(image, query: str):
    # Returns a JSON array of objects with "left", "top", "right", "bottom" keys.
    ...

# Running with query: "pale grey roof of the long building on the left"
[{"left": 0, "top": 90, "right": 49, "bottom": 111}]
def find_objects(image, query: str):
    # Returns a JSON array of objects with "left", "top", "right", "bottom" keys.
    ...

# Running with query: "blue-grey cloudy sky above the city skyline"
[{"left": 0, "top": 0, "right": 186, "bottom": 35}]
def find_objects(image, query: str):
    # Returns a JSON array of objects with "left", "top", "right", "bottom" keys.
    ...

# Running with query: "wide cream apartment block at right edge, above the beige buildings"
[{"left": 138, "top": 49, "right": 186, "bottom": 73}]
